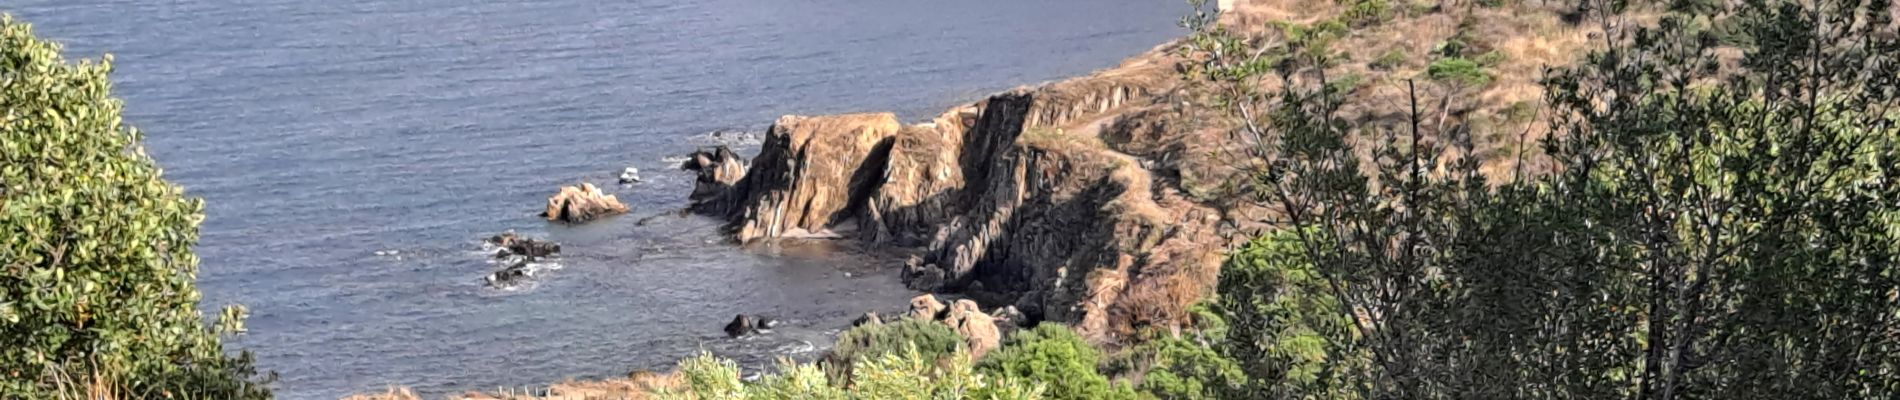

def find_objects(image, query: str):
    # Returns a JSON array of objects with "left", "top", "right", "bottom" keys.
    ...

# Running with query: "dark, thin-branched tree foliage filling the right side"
[{"left": 1186, "top": 0, "right": 1900, "bottom": 398}]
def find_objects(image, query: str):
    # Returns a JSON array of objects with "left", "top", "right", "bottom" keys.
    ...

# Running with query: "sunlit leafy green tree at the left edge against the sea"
[{"left": 0, "top": 15, "right": 268, "bottom": 398}]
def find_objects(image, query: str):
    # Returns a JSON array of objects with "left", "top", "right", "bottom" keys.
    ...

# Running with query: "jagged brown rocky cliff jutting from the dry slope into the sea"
[{"left": 688, "top": 47, "right": 1224, "bottom": 339}]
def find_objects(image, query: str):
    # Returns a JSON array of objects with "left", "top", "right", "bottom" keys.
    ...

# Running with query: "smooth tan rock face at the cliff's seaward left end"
[{"left": 733, "top": 112, "right": 901, "bottom": 241}]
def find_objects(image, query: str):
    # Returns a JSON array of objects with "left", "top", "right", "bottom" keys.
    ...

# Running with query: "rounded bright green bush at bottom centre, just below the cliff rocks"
[{"left": 977, "top": 324, "right": 1134, "bottom": 400}]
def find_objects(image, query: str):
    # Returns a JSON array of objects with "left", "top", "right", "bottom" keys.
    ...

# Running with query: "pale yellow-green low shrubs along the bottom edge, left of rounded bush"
[{"left": 657, "top": 345, "right": 1043, "bottom": 400}]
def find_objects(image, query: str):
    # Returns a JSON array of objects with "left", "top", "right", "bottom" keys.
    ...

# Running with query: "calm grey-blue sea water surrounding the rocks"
[{"left": 0, "top": 0, "right": 1186, "bottom": 398}]
